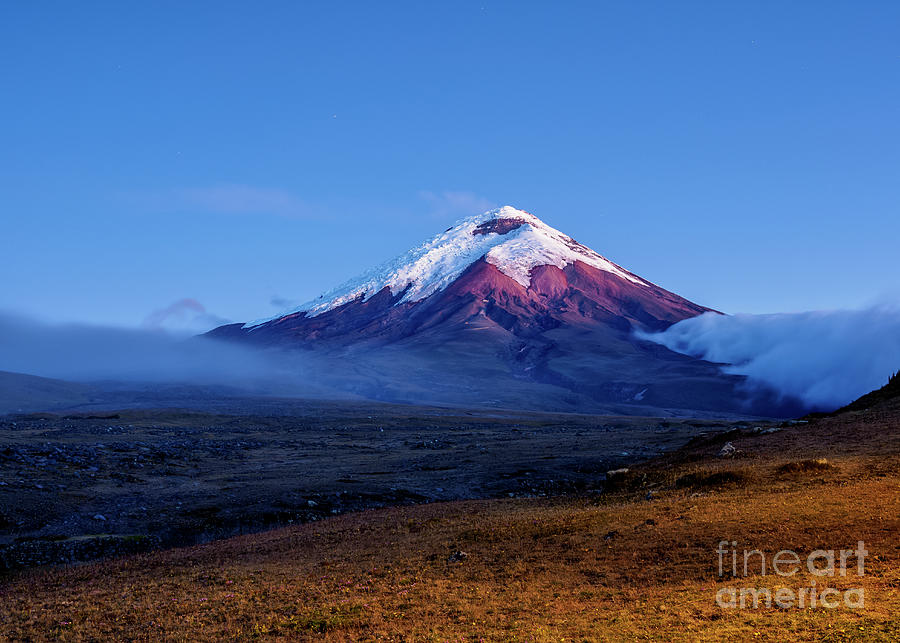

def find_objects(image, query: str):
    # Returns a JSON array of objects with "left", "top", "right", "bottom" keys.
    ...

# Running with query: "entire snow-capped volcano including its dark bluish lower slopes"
[{"left": 208, "top": 206, "right": 796, "bottom": 415}]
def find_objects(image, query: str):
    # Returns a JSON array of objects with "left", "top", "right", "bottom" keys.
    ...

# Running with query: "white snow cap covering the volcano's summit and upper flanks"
[{"left": 244, "top": 205, "right": 649, "bottom": 328}]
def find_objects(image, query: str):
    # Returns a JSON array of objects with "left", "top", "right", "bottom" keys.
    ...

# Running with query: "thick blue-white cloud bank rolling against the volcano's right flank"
[{"left": 642, "top": 306, "right": 900, "bottom": 410}]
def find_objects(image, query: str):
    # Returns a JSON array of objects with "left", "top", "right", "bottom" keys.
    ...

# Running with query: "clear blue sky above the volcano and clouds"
[{"left": 0, "top": 1, "right": 900, "bottom": 325}]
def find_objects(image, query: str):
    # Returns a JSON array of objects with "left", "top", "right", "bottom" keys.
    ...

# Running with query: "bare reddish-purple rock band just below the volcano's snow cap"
[{"left": 212, "top": 258, "right": 709, "bottom": 345}]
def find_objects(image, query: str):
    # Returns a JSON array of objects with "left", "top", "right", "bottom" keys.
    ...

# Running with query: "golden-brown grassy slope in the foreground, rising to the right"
[{"left": 0, "top": 405, "right": 900, "bottom": 641}]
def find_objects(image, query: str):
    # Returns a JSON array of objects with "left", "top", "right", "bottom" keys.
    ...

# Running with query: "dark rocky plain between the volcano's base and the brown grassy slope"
[{"left": 0, "top": 403, "right": 750, "bottom": 568}]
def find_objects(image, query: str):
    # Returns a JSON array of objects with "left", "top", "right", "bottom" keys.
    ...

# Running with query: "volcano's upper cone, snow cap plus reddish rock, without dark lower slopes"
[{"left": 213, "top": 207, "right": 709, "bottom": 345}]
